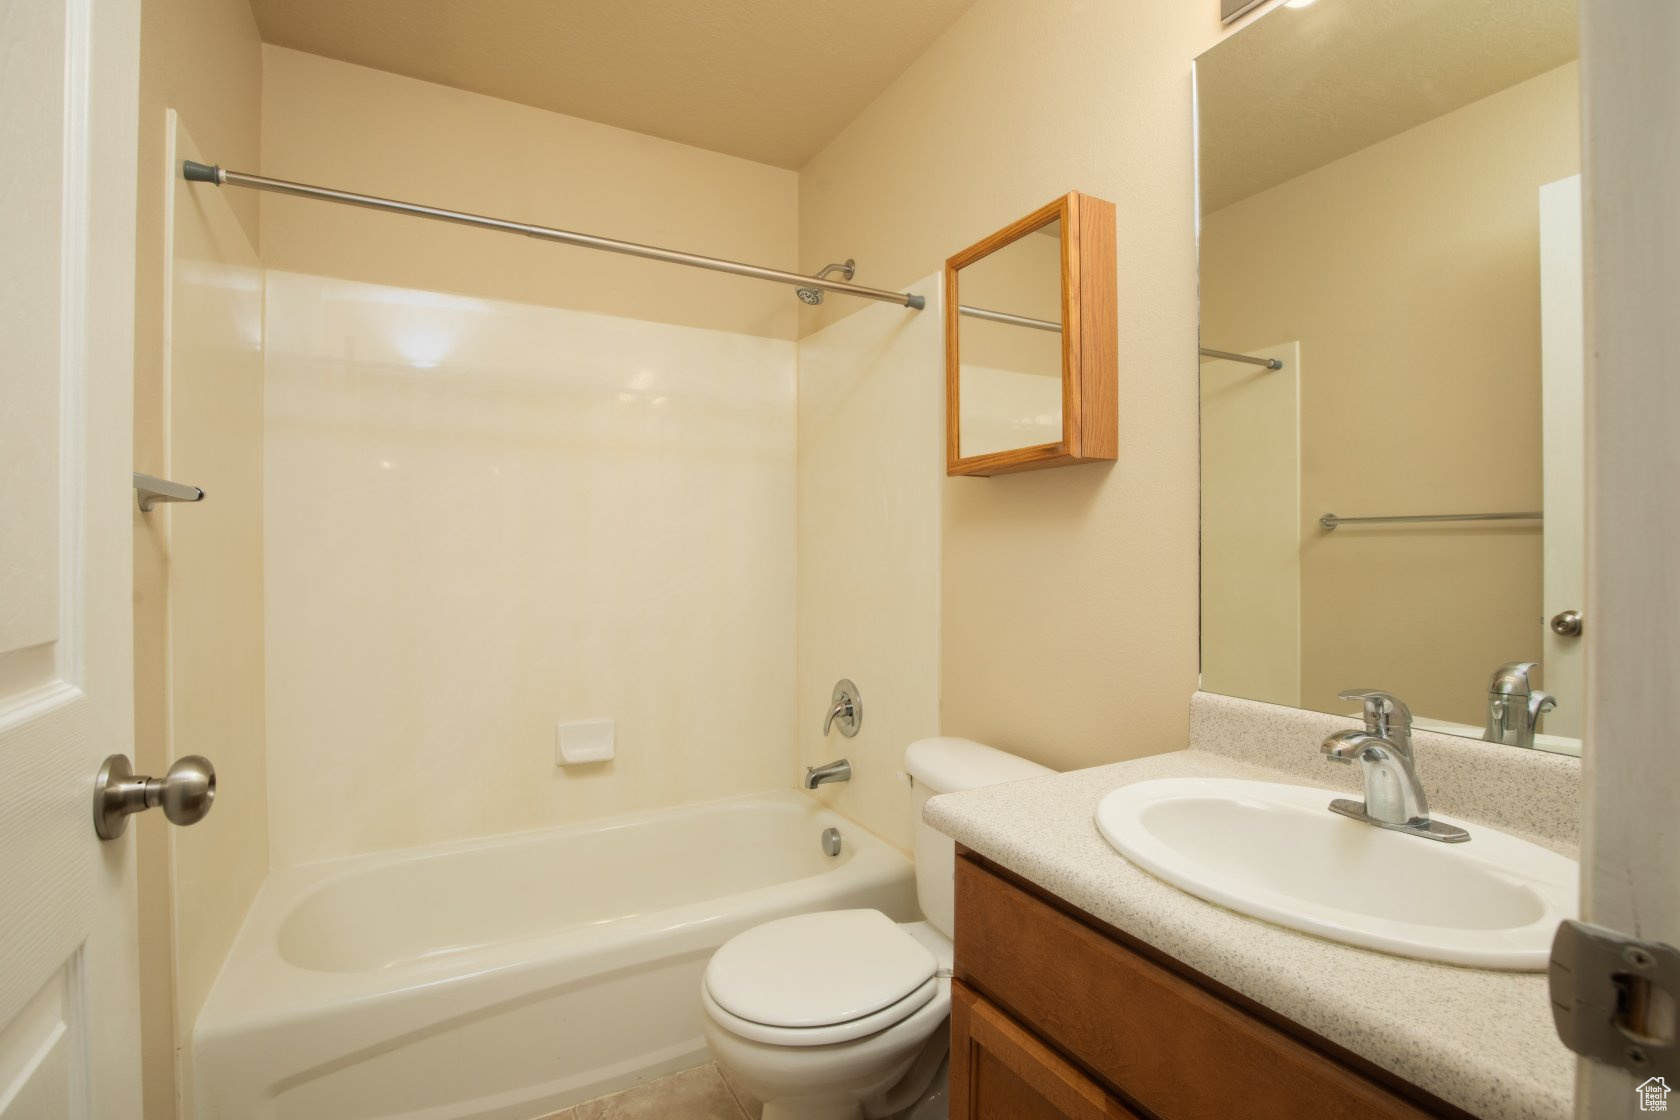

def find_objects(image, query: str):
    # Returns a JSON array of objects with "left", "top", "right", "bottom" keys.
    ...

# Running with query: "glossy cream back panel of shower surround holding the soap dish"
[{"left": 264, "top": 272, "right": 799, "bottom": 868}]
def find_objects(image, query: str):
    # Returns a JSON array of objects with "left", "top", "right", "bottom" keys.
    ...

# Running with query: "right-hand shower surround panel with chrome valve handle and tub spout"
[{"left": 795, "top": 274, "right": 944, "bottom": 850}]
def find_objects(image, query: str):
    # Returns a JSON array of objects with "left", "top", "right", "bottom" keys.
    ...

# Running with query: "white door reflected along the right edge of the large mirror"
[{"left": 1541, "top": 175, "right": 1586, "bottom": 739}]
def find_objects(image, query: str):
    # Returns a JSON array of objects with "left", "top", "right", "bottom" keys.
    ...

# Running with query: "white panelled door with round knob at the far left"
[{"left": 0, "top": 0, "right": 139, "bottom": 1120}]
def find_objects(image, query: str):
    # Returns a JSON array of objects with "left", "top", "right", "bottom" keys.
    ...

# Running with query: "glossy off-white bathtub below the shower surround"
[{"left": 193, "top": 791, "right": 916, "bottom": 1120}]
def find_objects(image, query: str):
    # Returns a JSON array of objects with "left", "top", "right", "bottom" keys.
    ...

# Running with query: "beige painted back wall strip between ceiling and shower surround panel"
[{"left": 262, "top": 47, "right": 800, "bottom": 339}]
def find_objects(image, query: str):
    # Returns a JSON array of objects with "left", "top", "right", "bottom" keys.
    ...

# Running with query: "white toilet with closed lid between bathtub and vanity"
[{"left": 701, "top": 739, "right": 1052, "bottom": 1120}]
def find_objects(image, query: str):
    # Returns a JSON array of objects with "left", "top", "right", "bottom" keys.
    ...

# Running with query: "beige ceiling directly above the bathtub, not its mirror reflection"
[{"left": 250, "top": 0, "right": 974, "bottom": 168}]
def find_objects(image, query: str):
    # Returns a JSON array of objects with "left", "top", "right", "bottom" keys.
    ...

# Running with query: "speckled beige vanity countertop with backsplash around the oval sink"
[{"left": 924, "top": 693, "right": 1579, "bottom": 1120}]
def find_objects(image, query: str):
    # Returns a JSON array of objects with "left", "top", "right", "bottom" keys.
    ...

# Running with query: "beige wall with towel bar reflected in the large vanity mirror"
[{"left": 1201, "top": 64, "right": 1579, "bottom": 724}]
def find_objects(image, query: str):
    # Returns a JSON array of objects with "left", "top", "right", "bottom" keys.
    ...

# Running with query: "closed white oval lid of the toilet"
[{"left": 706, "top": 910, "right": 939, "bottom": 1028}]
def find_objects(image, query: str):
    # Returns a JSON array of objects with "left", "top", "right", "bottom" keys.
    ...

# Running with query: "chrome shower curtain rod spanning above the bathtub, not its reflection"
[{"left": 181, "top": 160, "right": 927, "bottom": 311}]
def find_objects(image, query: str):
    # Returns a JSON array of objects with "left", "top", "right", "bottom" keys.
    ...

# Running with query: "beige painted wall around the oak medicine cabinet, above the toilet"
[{"left": 800, "top": 0, "right": 1243, "bottom": 767}]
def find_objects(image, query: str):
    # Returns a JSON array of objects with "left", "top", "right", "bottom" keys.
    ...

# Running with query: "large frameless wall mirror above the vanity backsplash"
[{"left": 1196, "top": 0, "right": 1591, "bottom": 752}]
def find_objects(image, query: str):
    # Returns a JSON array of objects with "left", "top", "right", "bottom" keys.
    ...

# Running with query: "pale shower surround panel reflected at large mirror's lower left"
[{"left": 1201, "top": 343, "right": 1302, "bottom": 707}]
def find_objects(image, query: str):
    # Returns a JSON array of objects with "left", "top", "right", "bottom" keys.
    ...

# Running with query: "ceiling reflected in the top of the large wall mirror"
[{"left": 1196, "top": 0, "right": 1579, "bottom": 213}]
